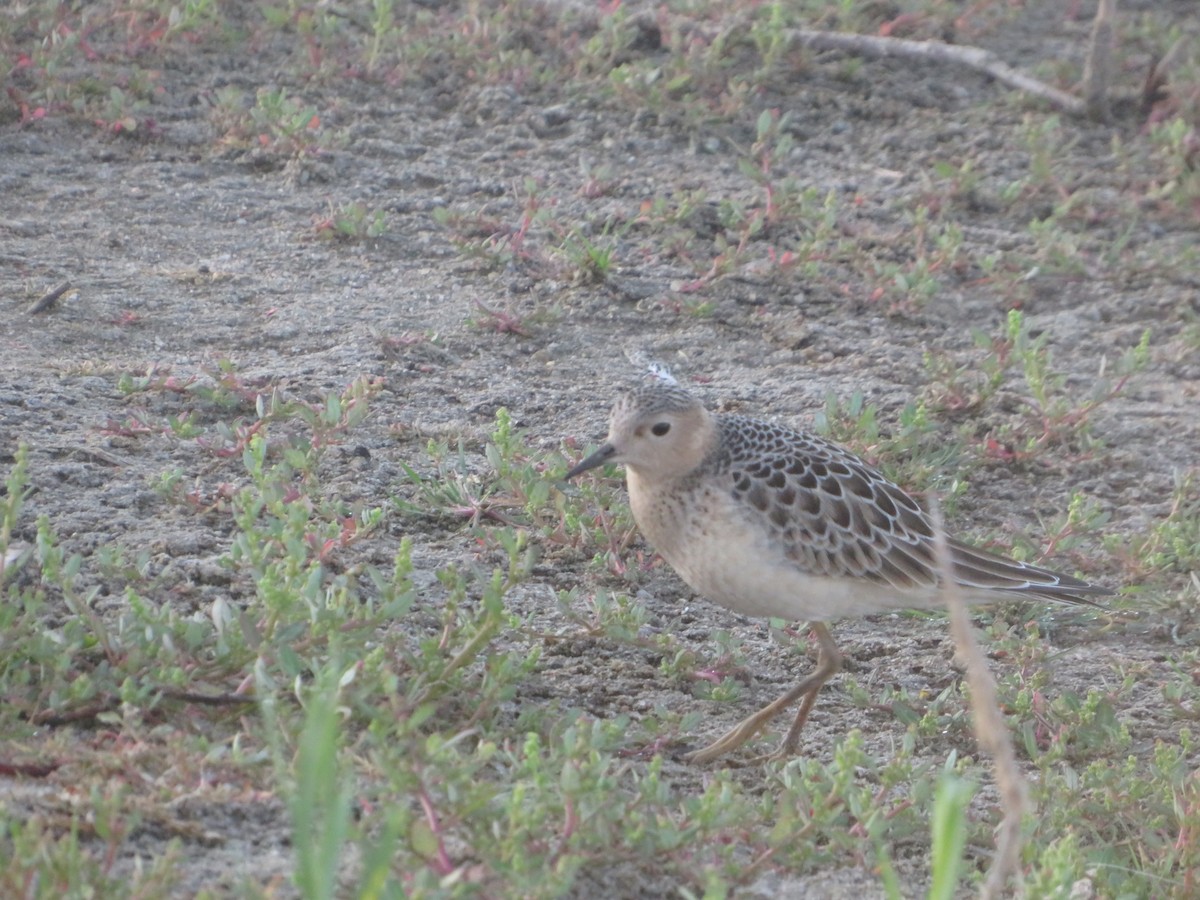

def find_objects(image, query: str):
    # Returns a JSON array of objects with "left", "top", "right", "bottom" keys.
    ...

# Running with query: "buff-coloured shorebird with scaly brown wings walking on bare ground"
[{"left": 564, "top": 370, "right": 1115, "bottom": 763}]
